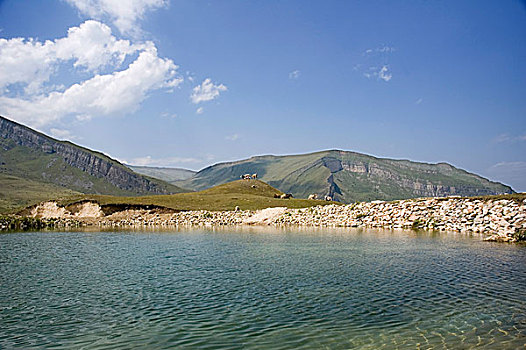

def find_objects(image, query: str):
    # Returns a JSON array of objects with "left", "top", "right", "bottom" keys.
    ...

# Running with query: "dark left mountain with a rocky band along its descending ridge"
[{"left": 0, "top": 117, "right": 184, "bottom": 212}]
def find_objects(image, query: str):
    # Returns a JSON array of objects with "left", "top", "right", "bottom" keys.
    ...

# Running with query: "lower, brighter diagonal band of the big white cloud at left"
[{"left": 0, "top": 47, "right": 182, "bottom": 127}]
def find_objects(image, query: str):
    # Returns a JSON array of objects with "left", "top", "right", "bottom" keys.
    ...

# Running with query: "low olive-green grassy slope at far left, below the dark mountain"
[{"left": 0, "top": 173, "right": 80, "bottom": 214}]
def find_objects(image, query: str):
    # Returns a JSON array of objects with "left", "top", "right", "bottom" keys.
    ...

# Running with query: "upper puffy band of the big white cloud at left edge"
[{"left": 0, "top": 21, "right": 153, "bottom": 94}]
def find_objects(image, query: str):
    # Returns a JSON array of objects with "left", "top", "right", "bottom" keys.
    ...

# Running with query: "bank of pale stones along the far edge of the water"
[{"left": 0, "top": 197, "right": 526, "bottom": 242}]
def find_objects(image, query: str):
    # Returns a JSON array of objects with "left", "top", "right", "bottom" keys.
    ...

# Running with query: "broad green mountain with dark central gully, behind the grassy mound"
[{"left": 176, "top": 150, "right": 513, "bottom": 203}]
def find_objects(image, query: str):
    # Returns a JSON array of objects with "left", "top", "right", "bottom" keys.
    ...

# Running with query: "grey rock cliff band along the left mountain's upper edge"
[{"left": 0, "top": 117, "right": 178, "bottom": 194}]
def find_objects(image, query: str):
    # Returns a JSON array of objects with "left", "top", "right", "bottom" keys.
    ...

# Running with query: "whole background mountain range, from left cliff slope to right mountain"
[{"left": 0, "top": 116, "right": 514, "bottom": 211}]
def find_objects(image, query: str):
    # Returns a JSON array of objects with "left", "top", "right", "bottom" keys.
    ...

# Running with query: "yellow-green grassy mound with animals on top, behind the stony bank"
[{"left": 56, "top": 180, "right": 333, "bottom": 211}]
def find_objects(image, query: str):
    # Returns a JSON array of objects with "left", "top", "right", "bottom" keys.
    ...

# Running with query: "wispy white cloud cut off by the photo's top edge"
[{"left": 65, "top": 0, "right": 169, "bottom": 34}]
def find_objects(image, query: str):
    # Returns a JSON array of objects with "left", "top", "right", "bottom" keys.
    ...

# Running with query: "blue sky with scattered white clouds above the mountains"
[{"left": 0, "top": 0, "right": 526, "bottom": 191}]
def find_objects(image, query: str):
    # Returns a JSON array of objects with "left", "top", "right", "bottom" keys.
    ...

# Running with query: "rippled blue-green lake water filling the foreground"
[{"left": 0, "top": 229, "right": 526, "bottom": 349}]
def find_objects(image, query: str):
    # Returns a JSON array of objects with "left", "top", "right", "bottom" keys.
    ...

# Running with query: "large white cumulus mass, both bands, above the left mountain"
[{"left": 0, "top": 20, "right": 182, "bottom": 127}]
